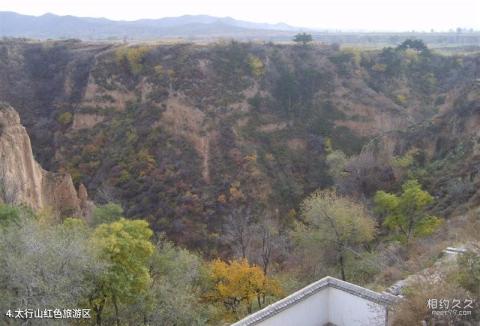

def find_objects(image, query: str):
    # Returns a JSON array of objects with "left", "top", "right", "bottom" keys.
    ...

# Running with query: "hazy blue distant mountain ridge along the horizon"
[{"left": 0, "top": 11, "right": 301, "bottom": 40}]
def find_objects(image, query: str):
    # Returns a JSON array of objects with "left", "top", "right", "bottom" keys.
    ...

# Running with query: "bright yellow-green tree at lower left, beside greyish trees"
[{"left": 90, "top": 218, "right": 155, "bottom": 325}]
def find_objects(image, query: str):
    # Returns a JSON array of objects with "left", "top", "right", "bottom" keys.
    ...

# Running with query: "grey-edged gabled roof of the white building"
[{"left": 232, "top": 276, "right": 397, "bottom": 326}]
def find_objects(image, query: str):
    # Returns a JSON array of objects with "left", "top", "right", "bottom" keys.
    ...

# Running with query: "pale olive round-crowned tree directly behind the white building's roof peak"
[{"left": 296, "top": 190, "right": 375, "bottom": 280}]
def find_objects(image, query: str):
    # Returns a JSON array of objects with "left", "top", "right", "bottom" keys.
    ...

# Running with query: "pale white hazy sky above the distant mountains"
[{"left": 0, "top": 0, "right": 480, "bottom": 31}]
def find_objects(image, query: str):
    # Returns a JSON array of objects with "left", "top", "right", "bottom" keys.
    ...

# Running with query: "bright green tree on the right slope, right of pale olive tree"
[{"left": 374, "top": 180, "right": 441, "bottom": 244}]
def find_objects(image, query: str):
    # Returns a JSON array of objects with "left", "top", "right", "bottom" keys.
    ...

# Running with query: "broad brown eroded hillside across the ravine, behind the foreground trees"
[{"left": 0, "top": 41, "right": 480, "bottom": 251}]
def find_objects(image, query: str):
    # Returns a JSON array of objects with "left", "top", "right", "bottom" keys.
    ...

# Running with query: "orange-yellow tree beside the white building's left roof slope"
[{"left": 206, "top": 259, "right": 282, "bottom": 321}]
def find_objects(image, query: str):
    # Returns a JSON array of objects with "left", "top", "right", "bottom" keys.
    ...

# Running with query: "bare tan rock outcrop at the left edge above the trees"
[{"left": 0, "top": 103, "right": 86, "bottom": 216}]
